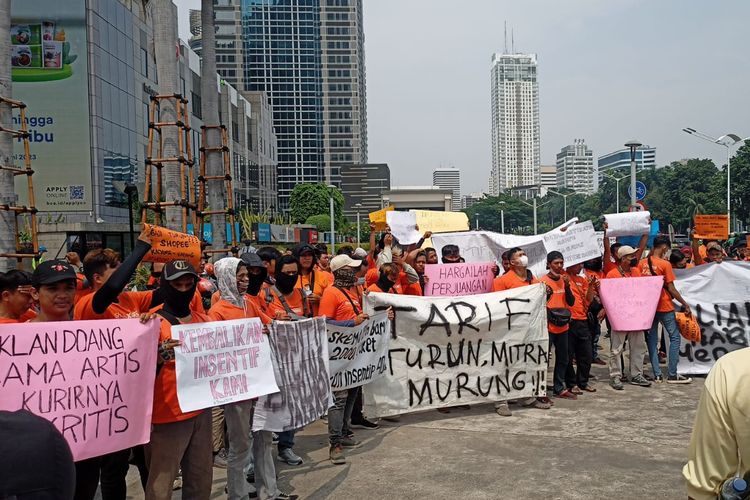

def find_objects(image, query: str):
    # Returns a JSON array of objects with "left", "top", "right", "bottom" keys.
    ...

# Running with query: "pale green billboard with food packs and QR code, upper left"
[{"left": 10, "top": 0, "right": 93, "bottom": 212}]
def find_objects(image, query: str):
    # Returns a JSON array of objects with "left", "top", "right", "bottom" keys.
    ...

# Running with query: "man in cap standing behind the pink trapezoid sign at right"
[{"left": 607, "top": 245, "right": 651, "bottom": 391}]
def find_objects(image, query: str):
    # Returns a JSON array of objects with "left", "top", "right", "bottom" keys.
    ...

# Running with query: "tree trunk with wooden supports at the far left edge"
[{"left": 0, "top": 0, "right": 16, "bottom": 271}]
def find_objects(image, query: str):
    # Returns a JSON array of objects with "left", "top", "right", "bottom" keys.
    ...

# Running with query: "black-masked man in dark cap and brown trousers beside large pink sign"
[{"left": 146, "top": 260, "right": 213, "bottom": 500}]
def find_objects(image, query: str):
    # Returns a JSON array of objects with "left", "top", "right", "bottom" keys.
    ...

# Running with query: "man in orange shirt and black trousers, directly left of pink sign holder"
[{"left": 565, "top": 264, "right": 598, "bottom": 394}]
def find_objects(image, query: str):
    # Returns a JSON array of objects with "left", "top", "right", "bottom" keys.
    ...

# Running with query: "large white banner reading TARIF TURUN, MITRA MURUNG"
[{"left": 363, "top": 284, "right": 549, "bottom": 417}]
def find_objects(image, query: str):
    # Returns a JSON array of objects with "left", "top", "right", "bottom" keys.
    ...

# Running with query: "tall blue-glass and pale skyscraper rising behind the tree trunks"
[{"left": 200, "top": 0, "right": 367, "bottom": 210}]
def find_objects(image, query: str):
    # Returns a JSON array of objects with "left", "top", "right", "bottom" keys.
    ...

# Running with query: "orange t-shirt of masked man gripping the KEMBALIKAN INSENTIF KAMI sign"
[{"left": 151, "top": 308, "right": 211, "bottom": 424}]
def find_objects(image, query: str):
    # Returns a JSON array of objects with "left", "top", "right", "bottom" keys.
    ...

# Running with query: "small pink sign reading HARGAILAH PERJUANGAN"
[{"left": 423, "top": 262, "right": 495, "bottom": 297}]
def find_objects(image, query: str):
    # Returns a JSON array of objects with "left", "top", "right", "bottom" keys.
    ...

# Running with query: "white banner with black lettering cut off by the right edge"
[{"left": 674, "top": 261, "right": 750, "bottom": 375}]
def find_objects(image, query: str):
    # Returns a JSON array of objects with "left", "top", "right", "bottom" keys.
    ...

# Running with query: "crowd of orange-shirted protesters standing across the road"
[{"left": 0, "top": 220, "right": 750, "bottom": 500}]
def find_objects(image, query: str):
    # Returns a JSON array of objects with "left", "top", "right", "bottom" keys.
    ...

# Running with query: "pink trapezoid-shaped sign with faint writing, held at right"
[{"left": 599, "top": 276, "right": 664, "bottom": 332}]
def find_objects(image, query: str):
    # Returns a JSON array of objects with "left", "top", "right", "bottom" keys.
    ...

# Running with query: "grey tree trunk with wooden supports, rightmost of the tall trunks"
[{"left": 201, "top": 0, "right": 226, "bottom": 254}]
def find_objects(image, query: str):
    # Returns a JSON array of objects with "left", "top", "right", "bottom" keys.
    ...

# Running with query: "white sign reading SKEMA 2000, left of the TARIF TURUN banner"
[{"left": 327, "top": 312, "right": 391, "bottom": 391}]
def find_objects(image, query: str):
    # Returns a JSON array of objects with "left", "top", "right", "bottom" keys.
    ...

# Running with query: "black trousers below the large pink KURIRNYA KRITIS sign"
[{"left": 74, "top": 448, "right": 130, "bottom": 500}]
